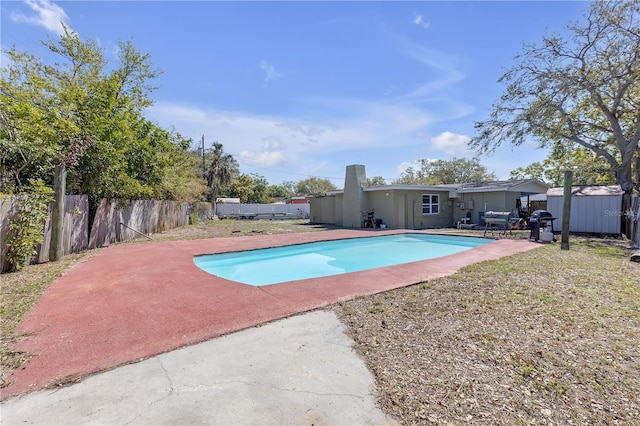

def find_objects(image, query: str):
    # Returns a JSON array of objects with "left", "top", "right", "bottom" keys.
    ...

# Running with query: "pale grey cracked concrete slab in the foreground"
[{"left": 0, "top": 311, "right": 397, "bottom": 426}]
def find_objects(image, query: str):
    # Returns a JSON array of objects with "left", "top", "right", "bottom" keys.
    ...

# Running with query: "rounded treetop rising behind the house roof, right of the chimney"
[{"left": 393, "top": 158, "right": 496, "bottom": 185}]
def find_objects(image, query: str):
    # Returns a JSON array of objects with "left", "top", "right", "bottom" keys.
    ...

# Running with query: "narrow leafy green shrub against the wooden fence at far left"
[{"left": 5, "top": 179, "right": 53, "bottom": 271}]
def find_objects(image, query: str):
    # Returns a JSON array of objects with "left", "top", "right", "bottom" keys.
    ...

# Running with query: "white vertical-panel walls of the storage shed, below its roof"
[{"left": 547, "top": 195, "right": 622, "bottom": 234}]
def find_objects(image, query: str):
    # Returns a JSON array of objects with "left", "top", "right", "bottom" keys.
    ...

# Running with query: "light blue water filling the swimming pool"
[{"left": 194, "top": 234, "right": 492, "bottom": 286}]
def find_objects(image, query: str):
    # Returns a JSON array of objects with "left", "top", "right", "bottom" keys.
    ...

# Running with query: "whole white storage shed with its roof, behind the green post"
[{"left": 547, "top": 185, "right": 624, "bottom": 235}]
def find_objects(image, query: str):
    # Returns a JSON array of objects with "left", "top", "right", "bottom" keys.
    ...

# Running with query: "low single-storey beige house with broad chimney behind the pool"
[{"left": 310, "top": 164, "right": 549, "bottom": 229}]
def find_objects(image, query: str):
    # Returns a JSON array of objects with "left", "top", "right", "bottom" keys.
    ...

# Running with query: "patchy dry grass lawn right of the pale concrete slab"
[{"left": 335, "top": 237, "right": 640, "bottom": 425}]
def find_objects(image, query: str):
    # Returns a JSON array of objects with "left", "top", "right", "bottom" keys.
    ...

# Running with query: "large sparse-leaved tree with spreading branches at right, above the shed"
[{"left": 470, "top": 0, "right": 640, "bottom": 193}]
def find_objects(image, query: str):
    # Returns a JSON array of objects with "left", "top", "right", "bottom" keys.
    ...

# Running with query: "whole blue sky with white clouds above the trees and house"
[{"left": 0, "top": 0, "right": 589, "bottom": 187}]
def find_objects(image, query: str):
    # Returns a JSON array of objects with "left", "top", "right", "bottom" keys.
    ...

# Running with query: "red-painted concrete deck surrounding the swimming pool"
[{"left": 0, "top": 230, "right": 539, "bottom": 398}]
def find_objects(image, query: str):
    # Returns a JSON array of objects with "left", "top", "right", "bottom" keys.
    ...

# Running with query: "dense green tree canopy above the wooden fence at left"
[{"left": 0, "top": 28, "right": 194, "bottom": 199}]
